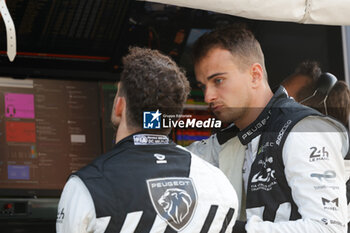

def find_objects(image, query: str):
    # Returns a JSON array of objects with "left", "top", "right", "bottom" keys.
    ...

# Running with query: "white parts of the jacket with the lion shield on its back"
[{"left": 56, "top": 146, "right": 238, "bottom": 233}]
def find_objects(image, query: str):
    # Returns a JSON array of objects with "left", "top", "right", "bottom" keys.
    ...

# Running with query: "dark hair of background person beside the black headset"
[{"left": 282, "top": 61, "right": 322, "bottom": 101}]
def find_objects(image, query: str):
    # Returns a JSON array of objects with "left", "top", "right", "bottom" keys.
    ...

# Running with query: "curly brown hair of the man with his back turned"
[{"left": 119, "top": 47, "right": 190, "bottom": 133}]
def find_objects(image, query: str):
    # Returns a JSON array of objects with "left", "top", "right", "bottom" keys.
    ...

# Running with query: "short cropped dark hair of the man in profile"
[{"left": 192, "top": 24, "right": 267, "bottom": 79}]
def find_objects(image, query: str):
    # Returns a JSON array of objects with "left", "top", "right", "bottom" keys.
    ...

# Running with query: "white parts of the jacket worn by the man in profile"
[{"left": 188, "top": 116, "right": 350, "bottom": 233}]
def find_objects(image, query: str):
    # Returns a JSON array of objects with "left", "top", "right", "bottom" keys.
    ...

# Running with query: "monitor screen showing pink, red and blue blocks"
[{"left": 0, "top": 78, "right": 102, "bottom": 196}]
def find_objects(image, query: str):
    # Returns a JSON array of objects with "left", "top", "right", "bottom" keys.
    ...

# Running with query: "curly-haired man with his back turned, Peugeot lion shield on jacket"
[{"left": 56, "top": 48, "right": 238, "bottom": 233}]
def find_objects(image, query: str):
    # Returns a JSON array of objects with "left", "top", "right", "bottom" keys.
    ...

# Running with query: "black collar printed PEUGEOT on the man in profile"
[{"left": 238, "top": 86, "right": 288, "bottom": 145}]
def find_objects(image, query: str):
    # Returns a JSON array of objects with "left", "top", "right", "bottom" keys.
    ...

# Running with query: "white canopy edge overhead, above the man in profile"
[{"left": 146, "top": 0, "right": 350, "bottom": 25}]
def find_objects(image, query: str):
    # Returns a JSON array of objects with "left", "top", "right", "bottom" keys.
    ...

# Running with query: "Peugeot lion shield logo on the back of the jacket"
[{"left": 147, "top": 177, "right": 197, "bottom": 231}]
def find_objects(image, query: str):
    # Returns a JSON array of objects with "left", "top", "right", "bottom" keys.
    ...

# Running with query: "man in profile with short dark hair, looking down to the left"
[{"left": 189, "top": 26, "right": 349, "bottom": 233}]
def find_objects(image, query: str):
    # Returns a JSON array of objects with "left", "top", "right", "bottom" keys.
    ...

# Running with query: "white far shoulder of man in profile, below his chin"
[{"left": 186, "top": 134, "right": 221, "bottom": 167}]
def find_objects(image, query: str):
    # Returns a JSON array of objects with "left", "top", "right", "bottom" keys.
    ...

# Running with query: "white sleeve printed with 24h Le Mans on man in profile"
[{"left": 246, "top": 117, "right": 348, "bottom": 233}]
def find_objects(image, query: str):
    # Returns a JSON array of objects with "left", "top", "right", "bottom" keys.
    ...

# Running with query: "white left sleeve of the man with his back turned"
[{"left": 56, "top": 176, "right": 110, "bottom": 233}]
